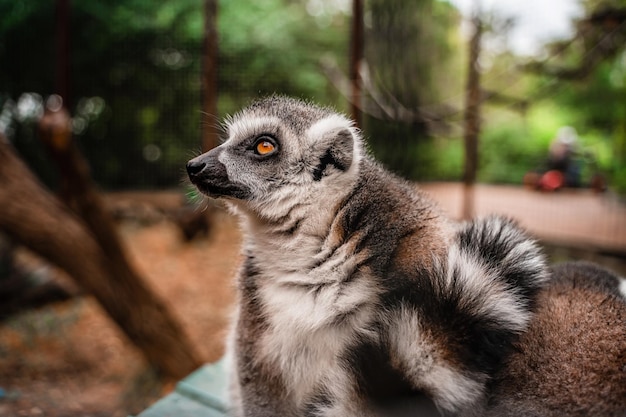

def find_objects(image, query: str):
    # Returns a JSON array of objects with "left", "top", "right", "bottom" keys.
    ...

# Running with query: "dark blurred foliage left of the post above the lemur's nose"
[{"left": 0, "top": 0, "right": 200, "bottom": 188}]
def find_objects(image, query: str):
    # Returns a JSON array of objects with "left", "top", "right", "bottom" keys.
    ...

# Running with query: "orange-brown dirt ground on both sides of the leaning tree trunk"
[{"left": 0, "top": 202, "right": 240, "bottom": 417}]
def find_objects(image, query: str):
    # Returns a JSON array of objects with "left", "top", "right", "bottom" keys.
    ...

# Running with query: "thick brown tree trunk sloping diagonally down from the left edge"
[{"left": 0, "top": 132, "right": 201, "bottom": 379}]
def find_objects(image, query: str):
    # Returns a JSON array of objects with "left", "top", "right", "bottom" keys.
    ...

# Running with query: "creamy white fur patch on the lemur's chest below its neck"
[{"left": 250, "top": 240, "right": 378, "bottom": 406}]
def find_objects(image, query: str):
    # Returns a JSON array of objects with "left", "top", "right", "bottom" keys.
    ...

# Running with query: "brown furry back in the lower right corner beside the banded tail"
[{"left": 489, "top": 262, "right": 626, "bottom": 417}]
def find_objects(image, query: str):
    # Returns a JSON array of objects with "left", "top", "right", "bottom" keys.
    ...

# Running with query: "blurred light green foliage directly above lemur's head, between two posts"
[{"left": 219, "top": 0, "right": 349, "bottom": 114}]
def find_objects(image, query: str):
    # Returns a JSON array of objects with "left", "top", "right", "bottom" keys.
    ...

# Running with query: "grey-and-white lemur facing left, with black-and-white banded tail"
[{"left": 187, "top": 96, "right": 624, "bottom": 417}]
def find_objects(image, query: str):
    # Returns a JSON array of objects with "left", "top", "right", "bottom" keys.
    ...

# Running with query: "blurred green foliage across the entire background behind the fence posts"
[{"left": 0, "top": 0, "right": 626, "bottom": 192}]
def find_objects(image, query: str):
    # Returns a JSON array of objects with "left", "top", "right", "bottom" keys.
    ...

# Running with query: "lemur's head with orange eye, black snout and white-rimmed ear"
[{"left": 187, "top": 96, "right": 362, "bottom": 216}]
